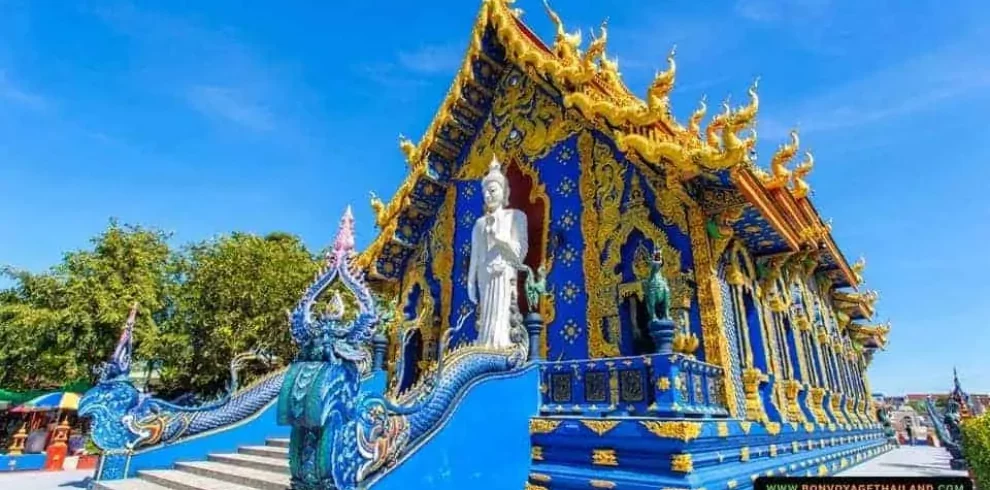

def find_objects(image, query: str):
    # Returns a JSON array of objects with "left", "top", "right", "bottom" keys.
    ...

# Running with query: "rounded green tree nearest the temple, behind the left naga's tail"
[{"left": 155, "top": 233, "right": 317, "bottom": 394}]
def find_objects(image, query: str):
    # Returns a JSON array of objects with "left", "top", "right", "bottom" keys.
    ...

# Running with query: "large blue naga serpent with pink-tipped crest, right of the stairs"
[{"left": 278, "top": 208, "right": 526, "bottom": 490}]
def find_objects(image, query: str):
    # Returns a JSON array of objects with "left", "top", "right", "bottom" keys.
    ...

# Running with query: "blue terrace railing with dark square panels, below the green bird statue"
[{"left": 540, "top": 354, "right": 729, "bottom": 417}]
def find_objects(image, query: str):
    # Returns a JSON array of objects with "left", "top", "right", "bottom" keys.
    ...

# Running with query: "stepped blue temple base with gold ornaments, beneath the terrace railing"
[{"left": 526, "top": 416, "right": 895, "bottom": 490}]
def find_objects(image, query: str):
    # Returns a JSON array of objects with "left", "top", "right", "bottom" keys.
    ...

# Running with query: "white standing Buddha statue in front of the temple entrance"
[{"left": 468, "top": 157, "right": 528, "bottom": 348}]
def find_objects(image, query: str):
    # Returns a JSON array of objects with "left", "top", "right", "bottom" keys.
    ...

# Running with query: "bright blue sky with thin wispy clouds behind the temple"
[{"left": 0, "top": 0, "right": 990, "bottom": 393}]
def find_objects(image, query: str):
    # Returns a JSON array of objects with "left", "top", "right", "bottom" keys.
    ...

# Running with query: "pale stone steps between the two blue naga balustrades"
[{"left": 93, "top": 439, "right": 289, "bottom": 490}]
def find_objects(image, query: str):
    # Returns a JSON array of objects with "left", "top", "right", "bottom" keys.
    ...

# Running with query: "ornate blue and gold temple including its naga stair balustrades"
[{"left": 83, "top": 0, "right": 892, "bottom": 490}]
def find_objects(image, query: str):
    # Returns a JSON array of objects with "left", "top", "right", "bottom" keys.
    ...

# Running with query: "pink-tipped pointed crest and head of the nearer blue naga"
[{"left": 289, "top": 206, "right": 379, "bottom": 366}]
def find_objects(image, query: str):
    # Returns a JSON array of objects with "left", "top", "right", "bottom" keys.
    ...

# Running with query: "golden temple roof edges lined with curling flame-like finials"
[{"left": 357, "top": 0, "right": 860, "bottom": 286}]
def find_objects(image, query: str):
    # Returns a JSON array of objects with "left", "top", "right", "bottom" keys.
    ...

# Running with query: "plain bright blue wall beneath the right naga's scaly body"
[{"left": 371, "top": 365, "right": 539, "bottom": 490}]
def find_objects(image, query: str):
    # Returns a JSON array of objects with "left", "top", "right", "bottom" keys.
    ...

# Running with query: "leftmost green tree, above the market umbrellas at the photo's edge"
[{"left": 0, "top": 220, "right": 173, "bottom": 389}]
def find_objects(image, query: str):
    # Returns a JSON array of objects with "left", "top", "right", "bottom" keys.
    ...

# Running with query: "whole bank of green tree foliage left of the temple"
[{"left": 0, "top": 221, "right": 317, "bottom": 394}]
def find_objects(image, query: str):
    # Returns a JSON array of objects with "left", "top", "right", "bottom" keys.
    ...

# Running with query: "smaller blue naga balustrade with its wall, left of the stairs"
[{"left": 79, "top": 305, "right": 288, "bottom": 481}]
